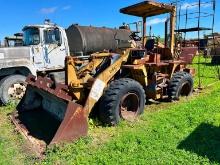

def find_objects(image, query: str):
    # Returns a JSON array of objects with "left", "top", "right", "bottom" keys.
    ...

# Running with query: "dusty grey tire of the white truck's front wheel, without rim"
[{"left": 0, "top": 75, "right": 26, "bottom": 105}]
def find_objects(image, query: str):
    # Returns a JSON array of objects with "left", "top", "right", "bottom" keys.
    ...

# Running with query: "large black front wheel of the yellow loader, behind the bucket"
[{"left": 99, "top": 78, "right": 146, "bottom": 125}]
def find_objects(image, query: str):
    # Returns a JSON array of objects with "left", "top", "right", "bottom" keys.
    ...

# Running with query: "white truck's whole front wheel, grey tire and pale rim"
[{"left": 0, "top": 75, "right": 26, "bottom": 105}]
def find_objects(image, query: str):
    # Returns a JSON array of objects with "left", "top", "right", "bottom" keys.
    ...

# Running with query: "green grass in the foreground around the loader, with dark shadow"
[{"left": 0, "top": 56, "right": 220, "bottom": 165}]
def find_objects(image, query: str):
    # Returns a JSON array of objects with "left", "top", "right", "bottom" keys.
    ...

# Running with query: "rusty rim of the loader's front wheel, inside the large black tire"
[{"left": 119, "top": 93, "right": 140, "bottom": 121}]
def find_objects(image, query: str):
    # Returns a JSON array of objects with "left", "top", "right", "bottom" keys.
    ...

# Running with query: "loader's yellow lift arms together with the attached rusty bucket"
[{"left": 11, "top": 49, "right": 130, "bottom": 154}]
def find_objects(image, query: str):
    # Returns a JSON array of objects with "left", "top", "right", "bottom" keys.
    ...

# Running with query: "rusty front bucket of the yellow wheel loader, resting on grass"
[{"left": 11, "top": 76, "right": 88, "bottom": 155}]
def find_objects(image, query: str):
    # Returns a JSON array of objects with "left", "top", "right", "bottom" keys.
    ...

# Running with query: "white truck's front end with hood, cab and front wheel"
[{"left": 0, "top": 21, "right": 69, "bottom": 104}]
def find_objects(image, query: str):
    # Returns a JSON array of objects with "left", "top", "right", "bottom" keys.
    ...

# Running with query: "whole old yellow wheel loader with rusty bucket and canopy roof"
[{"left": 11, "top": 1, "right": 194, "bottom": 153}]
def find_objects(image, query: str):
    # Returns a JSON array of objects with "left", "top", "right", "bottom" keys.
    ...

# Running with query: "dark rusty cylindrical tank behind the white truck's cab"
[{"left": 66, "top": 25, "right": 131, "bottom": 55}]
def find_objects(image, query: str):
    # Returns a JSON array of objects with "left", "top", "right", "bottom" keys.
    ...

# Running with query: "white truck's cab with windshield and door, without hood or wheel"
[{"left": 23, "top": 24, "right": 69, "bottom": 71}]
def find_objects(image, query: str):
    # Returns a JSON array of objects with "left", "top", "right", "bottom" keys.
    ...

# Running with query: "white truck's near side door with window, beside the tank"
[{"left": 44, "top": 28, "right": 67, "bottom": 69}]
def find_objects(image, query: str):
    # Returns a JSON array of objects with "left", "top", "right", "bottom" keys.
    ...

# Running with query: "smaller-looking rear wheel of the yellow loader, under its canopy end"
[{"left": 168, "top": 71, "right": 193, "bottom": 100}]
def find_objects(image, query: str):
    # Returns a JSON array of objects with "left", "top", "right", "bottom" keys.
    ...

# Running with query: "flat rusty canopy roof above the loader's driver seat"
[{"left": 120, "top": 1, "right": 175, "bottom": 17}]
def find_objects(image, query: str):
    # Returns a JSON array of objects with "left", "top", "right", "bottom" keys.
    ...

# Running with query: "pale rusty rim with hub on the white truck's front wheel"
[{"left": 8, "top": 83, "right": 26, "bottom": 101}]
